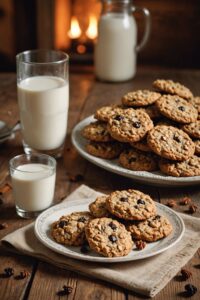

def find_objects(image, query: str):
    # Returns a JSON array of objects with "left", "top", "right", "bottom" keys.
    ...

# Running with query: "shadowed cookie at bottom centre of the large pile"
[{"left": 119, "top": 149, "right": 157, "bottom": 171}]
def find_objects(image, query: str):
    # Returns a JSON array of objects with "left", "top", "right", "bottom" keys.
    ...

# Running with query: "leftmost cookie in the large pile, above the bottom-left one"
[{"left": 82, "top": 121, "right": 113, "bottom": 142}]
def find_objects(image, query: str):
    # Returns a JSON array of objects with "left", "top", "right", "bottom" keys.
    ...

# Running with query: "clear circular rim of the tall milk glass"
[{"left": 16, "top": 49, "right": 69, "bottom": 65}]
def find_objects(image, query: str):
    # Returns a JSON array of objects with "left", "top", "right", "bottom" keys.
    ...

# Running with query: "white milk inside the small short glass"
[{"left": 11, "top": 163, "right": 56, "bottom": 212}]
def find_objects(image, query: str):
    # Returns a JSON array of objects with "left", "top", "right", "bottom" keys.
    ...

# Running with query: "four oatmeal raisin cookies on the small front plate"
[{"left": 51, "top": 189, "right": 172, "bottom": 257}]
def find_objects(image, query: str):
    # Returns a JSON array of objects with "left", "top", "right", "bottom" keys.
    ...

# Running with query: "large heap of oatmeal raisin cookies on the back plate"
[{"left": 82, "top": 79, "right": 200, "bottom": 177}]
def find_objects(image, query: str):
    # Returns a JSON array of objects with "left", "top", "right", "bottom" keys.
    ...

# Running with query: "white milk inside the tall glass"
[{"left": 17, "top": 75, "right": 69, "bottom": 150}]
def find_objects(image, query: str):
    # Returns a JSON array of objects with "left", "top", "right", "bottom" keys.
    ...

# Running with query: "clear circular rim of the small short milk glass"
[{"left": 9, "top": 154, "right": 57, "bottom": 173}]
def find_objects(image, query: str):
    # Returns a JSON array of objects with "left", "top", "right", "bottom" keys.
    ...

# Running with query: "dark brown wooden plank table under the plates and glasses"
[{"left": 0, "top": 68, "right": 200, "bottom": 300}]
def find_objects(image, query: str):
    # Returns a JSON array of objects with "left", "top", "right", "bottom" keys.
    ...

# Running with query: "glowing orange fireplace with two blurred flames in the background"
[{"left": 54, "top": 0, "right": 101, "bottom": 63}]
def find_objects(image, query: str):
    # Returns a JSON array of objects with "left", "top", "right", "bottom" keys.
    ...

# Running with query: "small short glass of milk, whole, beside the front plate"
[{"left": 9, "top": 154, "right": 56, "bottom": 218}]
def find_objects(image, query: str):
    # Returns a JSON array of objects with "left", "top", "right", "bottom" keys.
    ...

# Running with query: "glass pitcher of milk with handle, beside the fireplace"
[{"left": 94, "top": 0, "right": 150, "bottom": 82}]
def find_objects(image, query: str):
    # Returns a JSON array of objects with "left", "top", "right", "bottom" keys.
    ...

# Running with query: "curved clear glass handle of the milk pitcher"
[{"left": 132, "top": 6, "right": 151, "bottom": 52}]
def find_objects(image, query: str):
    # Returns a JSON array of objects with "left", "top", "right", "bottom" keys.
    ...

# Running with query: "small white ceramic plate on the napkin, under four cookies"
[{"left": 35, "top": 200, "right": 185, "bottom": 263}]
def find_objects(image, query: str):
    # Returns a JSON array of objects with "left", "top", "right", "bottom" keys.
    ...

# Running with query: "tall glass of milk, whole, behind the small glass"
[{"left": 16, "top": 50, "right": 69, "bottom": 157}]
